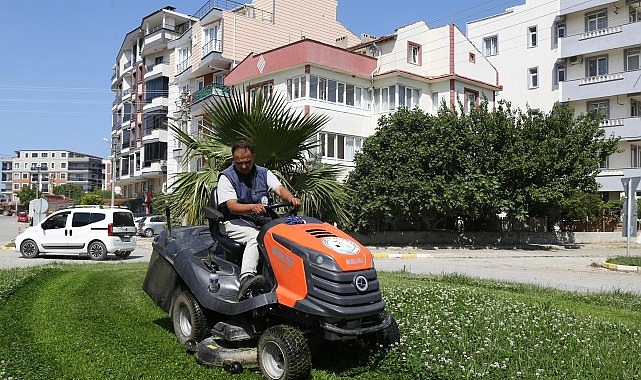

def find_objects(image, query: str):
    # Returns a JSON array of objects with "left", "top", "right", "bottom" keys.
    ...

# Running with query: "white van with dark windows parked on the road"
[{"left": 15, "top": 206, "right": 136, "bottom": 260}]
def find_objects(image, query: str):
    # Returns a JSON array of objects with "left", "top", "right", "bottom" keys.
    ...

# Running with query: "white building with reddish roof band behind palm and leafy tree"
[{"left": 225, "top": 21, "right": 501, "bottom": 174}]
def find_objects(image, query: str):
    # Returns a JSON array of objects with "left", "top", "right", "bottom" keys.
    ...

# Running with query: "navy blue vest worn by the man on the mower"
[{"left": 218, "top": 164, "right": 269, "bottom": 220}]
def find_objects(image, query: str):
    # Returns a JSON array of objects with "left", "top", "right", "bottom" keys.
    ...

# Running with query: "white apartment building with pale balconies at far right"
[{"left": 467, "top": 0, "right": 641, "bottom": 200}]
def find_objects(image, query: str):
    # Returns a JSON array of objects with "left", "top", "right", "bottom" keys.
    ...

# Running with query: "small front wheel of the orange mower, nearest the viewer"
[{"left": 258, "top": 325, "right": 312, "bottom": 380}]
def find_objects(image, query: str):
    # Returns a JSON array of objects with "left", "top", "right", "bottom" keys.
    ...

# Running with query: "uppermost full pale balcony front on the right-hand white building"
[{"left": 559, "top": 22, "right": 641, "bottom": 58}]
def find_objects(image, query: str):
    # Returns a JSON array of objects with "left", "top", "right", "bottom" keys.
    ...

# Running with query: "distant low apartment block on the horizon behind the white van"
[{"left": 2, "top": 150, "right": 104, "bottom": 201}]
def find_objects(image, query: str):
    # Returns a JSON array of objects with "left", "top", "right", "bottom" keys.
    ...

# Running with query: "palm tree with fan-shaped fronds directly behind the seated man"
[{"left": 163, "top": 91, "right": 348, "bottom": 224}]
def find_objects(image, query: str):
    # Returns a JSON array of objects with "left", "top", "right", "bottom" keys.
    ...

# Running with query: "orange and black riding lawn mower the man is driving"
[{"left": 143, "top": 197, "right": 400, "bottom": 379}]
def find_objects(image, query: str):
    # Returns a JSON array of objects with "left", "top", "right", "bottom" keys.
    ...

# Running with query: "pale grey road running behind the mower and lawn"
[{"left": 0, "top": 216, "right": 641, "bottom": 294}]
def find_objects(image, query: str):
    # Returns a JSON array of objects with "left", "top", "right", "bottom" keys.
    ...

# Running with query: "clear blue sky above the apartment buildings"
[{"left": 0, "top": 0, "right": 524, "bottom": 162}]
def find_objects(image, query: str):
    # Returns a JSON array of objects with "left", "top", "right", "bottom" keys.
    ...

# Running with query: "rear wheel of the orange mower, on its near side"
[{"left": 170, "top": 290, "right": 211, "bottom": 347}]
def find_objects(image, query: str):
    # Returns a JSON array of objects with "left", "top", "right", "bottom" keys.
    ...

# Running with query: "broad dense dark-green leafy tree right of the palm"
[{"left": 347, "top": 102, "right": 617, "bottom": 231}]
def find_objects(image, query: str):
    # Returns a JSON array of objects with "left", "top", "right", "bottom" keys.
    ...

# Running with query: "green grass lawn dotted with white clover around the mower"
[{"left": 0, "top": 263, "right": 641, "bottom": 380}]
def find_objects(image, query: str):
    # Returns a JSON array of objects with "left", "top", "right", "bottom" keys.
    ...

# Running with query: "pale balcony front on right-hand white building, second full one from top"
[{"left": 559, "top": 70, "right": 641, "bottom": 101}]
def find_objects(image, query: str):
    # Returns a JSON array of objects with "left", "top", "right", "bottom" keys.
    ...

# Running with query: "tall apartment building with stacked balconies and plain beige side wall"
[{"left": 111, "top": 0, "right": 359, "bottom": 198}]
